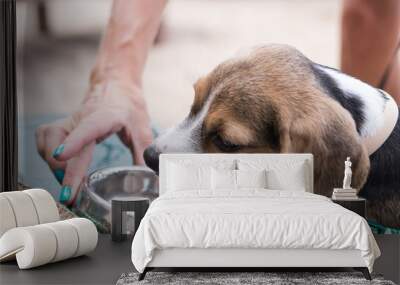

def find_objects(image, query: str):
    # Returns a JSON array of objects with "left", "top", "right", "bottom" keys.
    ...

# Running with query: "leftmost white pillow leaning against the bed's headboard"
[{"left": 167, "top": 163, "right": 211, "bottom": 191}]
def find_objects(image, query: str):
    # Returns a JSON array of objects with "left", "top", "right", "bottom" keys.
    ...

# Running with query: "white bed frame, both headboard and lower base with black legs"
[{"left": 139, "top": 154, "right": 371, "bottom": 280}]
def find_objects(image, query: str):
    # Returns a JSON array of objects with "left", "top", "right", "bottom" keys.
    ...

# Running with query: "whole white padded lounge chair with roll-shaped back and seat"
[{"left": 0, "top": 189, "right": 98, "bottom": 269}]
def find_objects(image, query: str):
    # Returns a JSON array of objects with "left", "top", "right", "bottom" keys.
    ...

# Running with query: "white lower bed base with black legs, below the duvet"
[{"left": 139, "top": 248, "right": 371, "bottom": 280}]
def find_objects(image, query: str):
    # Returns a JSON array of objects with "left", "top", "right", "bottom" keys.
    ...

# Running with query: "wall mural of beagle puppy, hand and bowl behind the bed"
[{"left": 17, "top": 0, "right": 400, "bottom": 234}]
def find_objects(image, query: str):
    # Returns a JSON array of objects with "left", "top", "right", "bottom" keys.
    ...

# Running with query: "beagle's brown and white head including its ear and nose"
[{"left": 144, "top": 45, "right": 368, "bottom": 195}]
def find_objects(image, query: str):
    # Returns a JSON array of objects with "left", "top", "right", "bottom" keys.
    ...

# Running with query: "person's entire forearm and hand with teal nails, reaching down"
[{"left": 36, "top": 0, "right": 166, "bottom": 204}]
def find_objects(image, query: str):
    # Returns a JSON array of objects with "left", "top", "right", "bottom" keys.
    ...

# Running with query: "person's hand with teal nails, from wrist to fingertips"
[{"left": 36, "top": 82, "right": 152, "bottom": 204}]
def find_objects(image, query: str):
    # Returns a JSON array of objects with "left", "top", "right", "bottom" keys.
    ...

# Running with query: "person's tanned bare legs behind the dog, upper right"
[{"left": 341, "top": 0, "right": 400, "bottom": 104}]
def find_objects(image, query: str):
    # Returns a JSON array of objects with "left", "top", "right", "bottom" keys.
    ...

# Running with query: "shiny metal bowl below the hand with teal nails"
[{"left": 77, "top": 166, "right": 159, "bottom": 232}]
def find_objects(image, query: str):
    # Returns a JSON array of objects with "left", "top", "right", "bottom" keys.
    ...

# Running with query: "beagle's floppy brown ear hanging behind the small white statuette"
[{"left": 280, "top": 96, "right": 369, "bottom": 196}]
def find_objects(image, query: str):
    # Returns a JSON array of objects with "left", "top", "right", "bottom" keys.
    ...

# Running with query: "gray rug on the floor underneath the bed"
[{"left": 117, "top": 272, "right": 395, "bottom": 285}]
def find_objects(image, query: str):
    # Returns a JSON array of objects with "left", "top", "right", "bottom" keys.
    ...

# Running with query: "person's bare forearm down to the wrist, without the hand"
[{"left": 90, "top": 0, "right": 166, "bottom": 88}]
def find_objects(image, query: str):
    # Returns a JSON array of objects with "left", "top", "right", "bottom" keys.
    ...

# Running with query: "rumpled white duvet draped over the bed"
[{"left": 132, "top": 189, "right": 380, "bottom": 272}]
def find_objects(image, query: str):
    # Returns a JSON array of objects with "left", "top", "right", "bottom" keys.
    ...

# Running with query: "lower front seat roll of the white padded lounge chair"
[{"left": 0, "top": 218, "right": 98, "bottom": 269}]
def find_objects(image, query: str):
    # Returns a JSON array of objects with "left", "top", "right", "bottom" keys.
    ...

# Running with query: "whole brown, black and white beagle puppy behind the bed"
[{"left": 144, "top": 44, "right": 400, "bottom": 228}]
